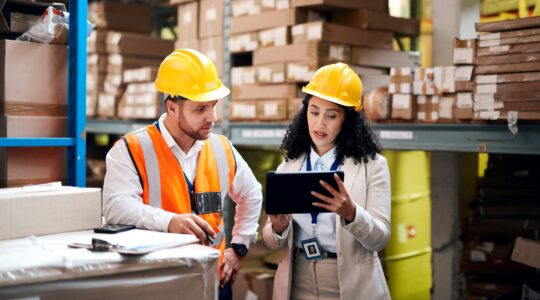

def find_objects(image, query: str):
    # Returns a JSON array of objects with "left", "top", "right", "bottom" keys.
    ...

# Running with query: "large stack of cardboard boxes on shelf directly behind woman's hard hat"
[{"left": 229, "top": 0, "right": 419, "bottom": 121}]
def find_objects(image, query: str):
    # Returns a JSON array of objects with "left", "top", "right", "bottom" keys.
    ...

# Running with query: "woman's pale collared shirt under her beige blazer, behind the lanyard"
[{"left": 292, "top": 147, "right": 337, "bottom": 252}]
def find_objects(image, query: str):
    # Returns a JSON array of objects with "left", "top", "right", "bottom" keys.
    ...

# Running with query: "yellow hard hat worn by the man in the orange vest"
[{"left": 154, "top": 49, "right": 230, "bottom": 102}]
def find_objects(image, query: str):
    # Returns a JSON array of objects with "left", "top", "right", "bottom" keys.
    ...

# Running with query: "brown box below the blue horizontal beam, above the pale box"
[{"left": 0, "top": 147, "right": 67, "bottom": 186}]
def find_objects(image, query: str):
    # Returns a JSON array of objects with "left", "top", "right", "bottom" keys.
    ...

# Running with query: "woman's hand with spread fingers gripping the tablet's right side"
[{"left": 311, "top": 174, "right": 356, "bottom": 222}]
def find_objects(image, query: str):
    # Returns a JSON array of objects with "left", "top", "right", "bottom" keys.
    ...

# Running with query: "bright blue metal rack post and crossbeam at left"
[{"left": 0, "top": 0, "right": 88, "bottom": 187}]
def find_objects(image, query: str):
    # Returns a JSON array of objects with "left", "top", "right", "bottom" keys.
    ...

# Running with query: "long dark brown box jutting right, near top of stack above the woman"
[{"left": 332, "top": 9, "right": 420, "bottom": 36}]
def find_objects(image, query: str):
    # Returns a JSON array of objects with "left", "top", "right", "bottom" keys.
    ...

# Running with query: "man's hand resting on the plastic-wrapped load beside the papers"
[{"left": 168, "top": 214, "right": 216, "bottom": 246}]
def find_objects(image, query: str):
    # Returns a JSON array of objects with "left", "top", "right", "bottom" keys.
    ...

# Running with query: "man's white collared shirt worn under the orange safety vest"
[{"left": 103, "top": 114, "right": 262, "bottom": 245}]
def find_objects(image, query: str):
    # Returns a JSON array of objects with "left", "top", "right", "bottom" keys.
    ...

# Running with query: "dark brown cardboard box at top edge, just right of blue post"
[{"left": 88, "top": 2, "right": 152, "bottom": 34}]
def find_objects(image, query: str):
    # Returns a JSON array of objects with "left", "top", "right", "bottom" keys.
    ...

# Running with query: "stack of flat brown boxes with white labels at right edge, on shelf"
[{"left": 474, "top": 17, "right": 540, "bottom": 120}]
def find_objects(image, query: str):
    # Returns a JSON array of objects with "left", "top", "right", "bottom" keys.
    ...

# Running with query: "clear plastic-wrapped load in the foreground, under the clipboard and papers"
[{"left": 0, "top": 231, "right": 219, "bottom": 299}]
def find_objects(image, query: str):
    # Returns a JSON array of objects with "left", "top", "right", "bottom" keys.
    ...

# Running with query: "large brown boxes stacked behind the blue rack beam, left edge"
[{"left": 0, "top": 40, "right": 68, "bottom": 187}]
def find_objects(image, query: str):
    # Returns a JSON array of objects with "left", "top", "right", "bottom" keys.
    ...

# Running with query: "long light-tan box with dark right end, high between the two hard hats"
[{"left": 231, "top": 9, "right": 307, "bottom": 34}]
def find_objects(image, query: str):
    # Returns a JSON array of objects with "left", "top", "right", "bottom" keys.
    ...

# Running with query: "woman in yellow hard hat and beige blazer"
[{"left": 263, "top": 63, "right": 390, "bottom": 299}]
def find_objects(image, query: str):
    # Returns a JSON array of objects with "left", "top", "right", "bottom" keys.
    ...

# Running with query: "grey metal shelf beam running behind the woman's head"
[{"left": 229, "top": 123, "right": 540, "bottom": 154}]
